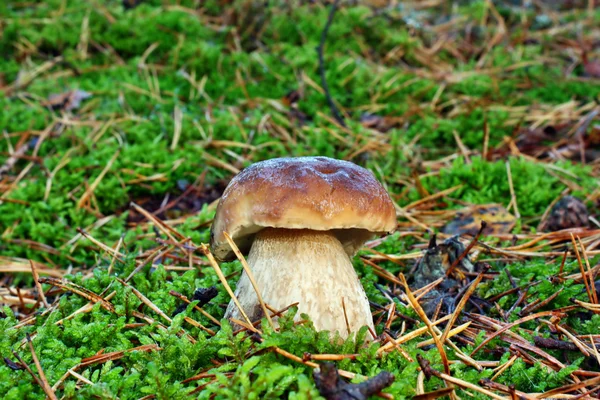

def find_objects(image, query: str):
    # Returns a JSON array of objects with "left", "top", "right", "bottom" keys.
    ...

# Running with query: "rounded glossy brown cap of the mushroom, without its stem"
[{"left": 210, "top": 157, "right": 397, "bottom": 261}]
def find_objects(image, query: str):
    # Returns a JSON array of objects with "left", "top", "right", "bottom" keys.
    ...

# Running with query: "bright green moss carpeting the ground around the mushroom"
[{"left": 0, "top": 0, "right": 600, "bottom": 399}]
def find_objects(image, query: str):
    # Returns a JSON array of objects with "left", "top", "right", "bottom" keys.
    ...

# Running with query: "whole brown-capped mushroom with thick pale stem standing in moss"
[{"left": 211, "top": 157, "right": 397, "bottom": 338}]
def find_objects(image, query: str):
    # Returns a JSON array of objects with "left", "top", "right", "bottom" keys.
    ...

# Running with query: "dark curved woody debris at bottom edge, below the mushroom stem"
[{"left": 313, "top": 363, "right": 394, "bottom": 400}]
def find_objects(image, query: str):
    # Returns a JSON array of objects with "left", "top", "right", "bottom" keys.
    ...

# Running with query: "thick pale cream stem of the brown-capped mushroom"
[{"left": 225, "top": 228, "right": 374, "bottom": 338}]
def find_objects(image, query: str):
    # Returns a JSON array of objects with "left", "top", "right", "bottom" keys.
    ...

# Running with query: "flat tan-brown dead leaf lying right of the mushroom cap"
[{"left": 442, "top": 204, "right": 516, "bottom": 236}]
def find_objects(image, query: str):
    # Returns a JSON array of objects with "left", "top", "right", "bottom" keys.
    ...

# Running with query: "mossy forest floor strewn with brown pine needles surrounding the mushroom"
[{"left": 0, "top": 0, "right": 600, "bottom": 399}]
